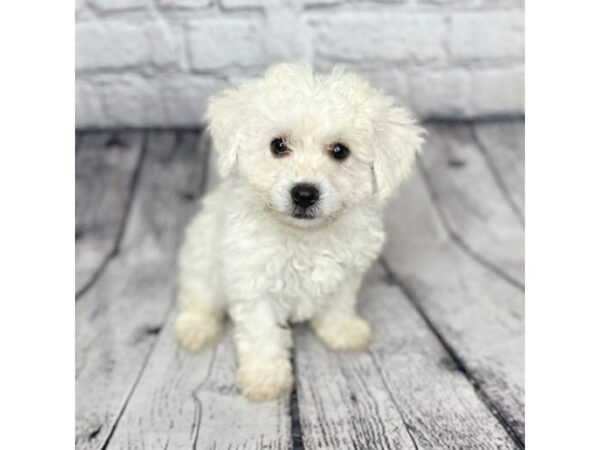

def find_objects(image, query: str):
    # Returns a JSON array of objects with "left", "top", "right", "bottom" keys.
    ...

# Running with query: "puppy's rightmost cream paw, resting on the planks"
[{"left": 313, "top": 316, "right": 371, "bottom": 351}]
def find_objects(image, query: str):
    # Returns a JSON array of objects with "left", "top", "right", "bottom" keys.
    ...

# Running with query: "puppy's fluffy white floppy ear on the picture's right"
[{"left": 373, "top": 107, "right": 425, "bottom": 199}]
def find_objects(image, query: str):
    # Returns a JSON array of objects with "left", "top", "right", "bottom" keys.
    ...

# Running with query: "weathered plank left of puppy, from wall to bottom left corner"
[{"left": 76, "top": 128, "right": 203, "bottom": 449}]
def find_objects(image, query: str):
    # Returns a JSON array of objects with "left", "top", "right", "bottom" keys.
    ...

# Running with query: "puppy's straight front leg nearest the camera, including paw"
[{"left": 230, "top": 301, "right": 294, "bottom": 401}]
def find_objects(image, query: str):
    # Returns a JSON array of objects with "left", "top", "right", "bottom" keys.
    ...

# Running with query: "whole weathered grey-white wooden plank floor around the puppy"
[{"left": 75, "top": 121, "right": 525, "bottom": 450}]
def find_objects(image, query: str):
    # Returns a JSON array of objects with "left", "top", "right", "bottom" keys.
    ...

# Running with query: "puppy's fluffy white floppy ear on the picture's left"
[{"left": 205, "top": 89, "right": 242, "bottom": 177}]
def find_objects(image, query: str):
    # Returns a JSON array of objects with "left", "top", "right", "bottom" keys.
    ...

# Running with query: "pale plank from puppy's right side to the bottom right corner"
[{"left": 384, "top": 173, "right": 524, "bottom": 446}]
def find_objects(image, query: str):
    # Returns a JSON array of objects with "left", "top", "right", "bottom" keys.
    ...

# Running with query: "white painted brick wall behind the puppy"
[{"left": 76, "top": 0, "right": 524, "bottom": 127}]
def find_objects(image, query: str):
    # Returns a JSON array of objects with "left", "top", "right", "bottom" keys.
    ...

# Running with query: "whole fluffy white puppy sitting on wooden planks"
[{"left": 175, "top": 64, "right": 423, "bottom": 400}]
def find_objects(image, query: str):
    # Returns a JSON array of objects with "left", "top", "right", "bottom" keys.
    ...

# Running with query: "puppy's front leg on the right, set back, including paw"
[{"left": 310, "top": 276, "right": 371, "bottom": 351}]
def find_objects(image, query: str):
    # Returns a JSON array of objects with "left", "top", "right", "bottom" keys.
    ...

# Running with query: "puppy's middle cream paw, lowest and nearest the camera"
[{"left": 237, "top": 359, "right": 294, "bottom": 402}]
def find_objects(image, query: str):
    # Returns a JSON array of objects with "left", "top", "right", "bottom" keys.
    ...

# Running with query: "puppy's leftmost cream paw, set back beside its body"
[{"left": 175, "top": 311, "right": 221, "bottom": 352}]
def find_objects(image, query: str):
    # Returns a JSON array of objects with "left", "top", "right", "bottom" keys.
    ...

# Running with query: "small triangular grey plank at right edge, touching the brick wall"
[{"left": 474, "top": 120, "right": 525, "bottom": 222}]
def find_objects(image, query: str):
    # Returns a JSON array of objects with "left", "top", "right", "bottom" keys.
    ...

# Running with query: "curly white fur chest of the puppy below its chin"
[{"left": 221, "top": 206, "right": 384, "bottom": 321}]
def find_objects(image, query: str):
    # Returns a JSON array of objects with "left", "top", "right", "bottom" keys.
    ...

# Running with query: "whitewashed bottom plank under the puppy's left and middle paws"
[{"left": 110, "top": 316, "right": 291, "bottom": 450}]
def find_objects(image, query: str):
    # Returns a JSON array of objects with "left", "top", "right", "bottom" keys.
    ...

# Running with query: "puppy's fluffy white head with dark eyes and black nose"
[{"left": 207, "top": 64, "right": 423, "bottom": 225}]
